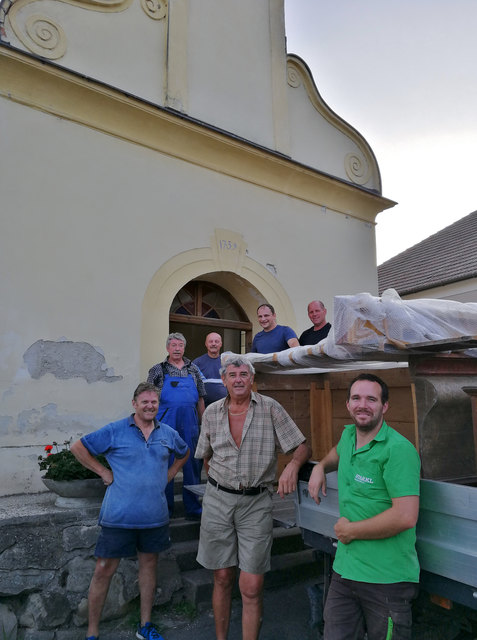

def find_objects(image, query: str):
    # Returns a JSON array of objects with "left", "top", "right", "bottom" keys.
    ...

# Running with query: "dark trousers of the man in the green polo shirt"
[{"left": 324, "top": 572, "right": 418, "bottom": 640}]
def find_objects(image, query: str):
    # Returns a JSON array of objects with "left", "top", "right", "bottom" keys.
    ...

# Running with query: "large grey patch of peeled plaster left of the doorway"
[{"left": 23, "top": 340, "right": 123, "bottom": 382}]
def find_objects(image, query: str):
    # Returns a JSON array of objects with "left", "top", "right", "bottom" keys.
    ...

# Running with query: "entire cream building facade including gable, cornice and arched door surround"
[{"left": 0, "top": 0, "right": 393, "bottom": 494}]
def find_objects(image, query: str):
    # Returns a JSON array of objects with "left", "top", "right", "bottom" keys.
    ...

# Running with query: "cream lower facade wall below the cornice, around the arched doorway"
[{"left": 0, "top": 84, "right": 377, "bottom": 493}]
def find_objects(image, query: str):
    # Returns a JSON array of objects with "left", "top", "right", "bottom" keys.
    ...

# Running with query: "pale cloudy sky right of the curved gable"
[{"left": 285, "top": 0, "right": 477, "bottom": 264}]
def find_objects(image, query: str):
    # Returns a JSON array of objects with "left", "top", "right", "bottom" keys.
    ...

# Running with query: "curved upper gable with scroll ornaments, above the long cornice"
[{"left": 0, "top": 0, "right": 381, "bottom": 193}]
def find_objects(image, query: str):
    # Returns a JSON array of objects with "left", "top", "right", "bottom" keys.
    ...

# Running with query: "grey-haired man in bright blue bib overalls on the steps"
[{"left": 147, "top": 333, "right": 206, "bottom": 520}]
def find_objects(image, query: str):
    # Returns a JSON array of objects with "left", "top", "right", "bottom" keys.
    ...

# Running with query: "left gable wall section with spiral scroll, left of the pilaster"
[{"left": 5, "top": 0, "right": 167, "bottom": 104}]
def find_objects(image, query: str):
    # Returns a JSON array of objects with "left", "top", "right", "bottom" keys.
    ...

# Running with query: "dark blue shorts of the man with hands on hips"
[{"left": 94, "top": 524, "right": 171, "bottom": 558}]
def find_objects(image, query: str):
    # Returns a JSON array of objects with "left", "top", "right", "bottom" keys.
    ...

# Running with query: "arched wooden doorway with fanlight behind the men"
[{"left": 169, "top": 280, "right": 252, "bottom": 360}]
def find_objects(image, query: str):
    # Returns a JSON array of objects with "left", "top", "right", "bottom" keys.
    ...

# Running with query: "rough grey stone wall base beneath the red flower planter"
[{"left": 0, "top": 493, "right": 182, "bottom": 640}]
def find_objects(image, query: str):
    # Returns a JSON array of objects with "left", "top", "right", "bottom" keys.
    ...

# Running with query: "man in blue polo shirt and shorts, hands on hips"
[{"left": 71, "top": 382, "right": 189, "bottom": 640}]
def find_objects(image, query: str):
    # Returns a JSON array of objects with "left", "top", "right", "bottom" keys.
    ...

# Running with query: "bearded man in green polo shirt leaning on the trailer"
[{"left": 308, "top": 373, "right": 420, "bottom": 640}]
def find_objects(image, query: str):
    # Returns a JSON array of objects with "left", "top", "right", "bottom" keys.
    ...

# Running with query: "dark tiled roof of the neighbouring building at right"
[{"left": 378, "top": 211, "right": 477, "bottom": 295}]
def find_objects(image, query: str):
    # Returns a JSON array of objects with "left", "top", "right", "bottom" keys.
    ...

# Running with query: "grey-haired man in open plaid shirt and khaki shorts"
[{"left": 195, "top": 356, "right": 311, "bottom": 640}]
